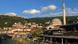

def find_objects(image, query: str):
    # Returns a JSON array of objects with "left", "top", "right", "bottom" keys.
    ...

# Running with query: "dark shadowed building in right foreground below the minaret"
[{"left": 41, "top": 23, "right": 78, "bottom": 44}]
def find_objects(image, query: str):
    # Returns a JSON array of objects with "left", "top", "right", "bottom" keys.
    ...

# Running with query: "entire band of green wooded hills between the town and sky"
[{"left": 0, "top": 15, "right": 78, "bottom": 27}]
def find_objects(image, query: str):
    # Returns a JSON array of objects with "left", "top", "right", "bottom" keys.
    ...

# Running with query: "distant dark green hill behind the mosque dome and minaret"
[{"left": 29, "top": 16, "right": 78, "bottom": 24}]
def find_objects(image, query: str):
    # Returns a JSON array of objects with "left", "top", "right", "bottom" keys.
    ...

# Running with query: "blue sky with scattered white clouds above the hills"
[{"left": 0, "top": 0, "right": 78, "bottom": 18}]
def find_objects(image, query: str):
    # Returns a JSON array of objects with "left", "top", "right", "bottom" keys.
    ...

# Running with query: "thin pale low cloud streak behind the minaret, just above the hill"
[{"left": 40, "top": 8, "right": 78, "bottom": 17}]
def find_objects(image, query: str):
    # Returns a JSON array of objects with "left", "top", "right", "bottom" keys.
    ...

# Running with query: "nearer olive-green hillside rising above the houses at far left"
[{"left": 0, "top": 15, "right": 28, "bottom": 27}]
